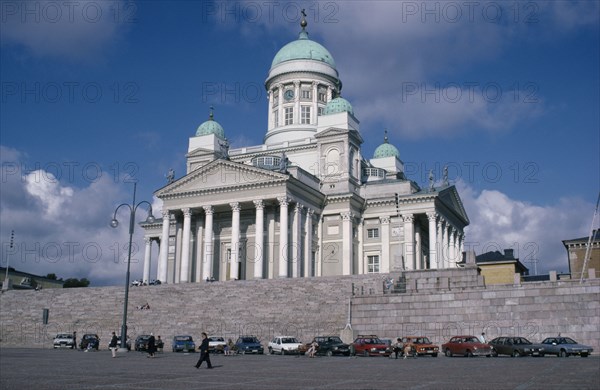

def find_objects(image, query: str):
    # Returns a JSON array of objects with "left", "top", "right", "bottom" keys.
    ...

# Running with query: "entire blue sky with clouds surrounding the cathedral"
[{"left": 0, "top": 1, "right": 600, "bottom": 285}]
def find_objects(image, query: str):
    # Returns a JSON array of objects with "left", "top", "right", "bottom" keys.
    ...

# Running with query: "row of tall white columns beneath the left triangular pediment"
[{"left": 144, "top": 197, "right": 314, "bottom": 283}]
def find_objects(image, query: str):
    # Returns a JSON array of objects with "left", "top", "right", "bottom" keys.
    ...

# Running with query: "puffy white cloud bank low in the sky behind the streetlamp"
[{"left": 0, "top": 147, "right": 160, "bottom": 286}]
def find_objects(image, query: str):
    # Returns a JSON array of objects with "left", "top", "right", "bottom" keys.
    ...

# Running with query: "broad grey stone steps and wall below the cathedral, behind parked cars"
[{"left": 0, "top": 268, "right": 600, "bottom": 352}]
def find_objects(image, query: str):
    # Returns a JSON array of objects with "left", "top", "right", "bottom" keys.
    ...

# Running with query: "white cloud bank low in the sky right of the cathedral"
[{"left": 457, "top": 181, "right": 594, "bottom": 274}]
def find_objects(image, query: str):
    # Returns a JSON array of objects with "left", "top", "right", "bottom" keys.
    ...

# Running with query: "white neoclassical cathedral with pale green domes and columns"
[{"left": 141, "top": 18, "right": 469, "bottom": 283}]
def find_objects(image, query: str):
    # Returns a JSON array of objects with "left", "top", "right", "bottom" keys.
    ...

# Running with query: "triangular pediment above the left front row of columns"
[{"left": 155, "top": 159, "right": 289, "bottom": 198}]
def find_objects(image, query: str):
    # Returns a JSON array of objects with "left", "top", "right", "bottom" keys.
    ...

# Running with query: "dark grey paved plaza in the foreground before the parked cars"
[{"left": 0, "top": 348, "right": 600, "bottom": 390}]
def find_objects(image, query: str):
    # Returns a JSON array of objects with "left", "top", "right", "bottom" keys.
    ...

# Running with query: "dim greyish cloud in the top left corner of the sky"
[{"left": 0, "top": 0, "right": 131, "bottom": 62}]
